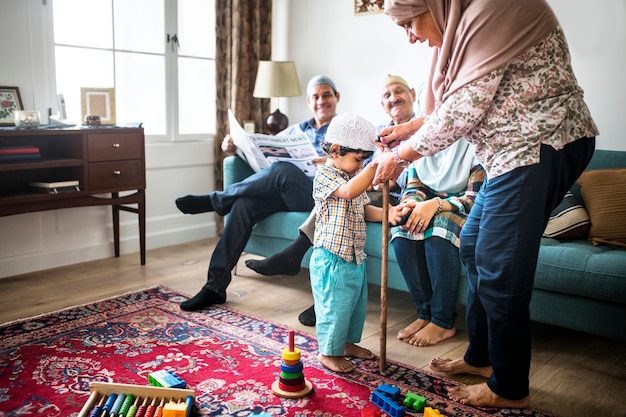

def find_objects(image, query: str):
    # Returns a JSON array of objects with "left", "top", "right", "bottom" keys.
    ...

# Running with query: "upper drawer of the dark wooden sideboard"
[{"left": 87, "top": 133, "right": 143, "bottom": 162}]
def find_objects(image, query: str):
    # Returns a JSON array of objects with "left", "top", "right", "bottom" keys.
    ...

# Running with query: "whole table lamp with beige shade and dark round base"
[{"left": 252, "top": 61, "right": 302, "bottom": 135}]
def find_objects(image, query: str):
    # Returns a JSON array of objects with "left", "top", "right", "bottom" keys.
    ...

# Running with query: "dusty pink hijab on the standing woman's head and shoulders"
[{"left": 385, "top": 0, "right": 558, "bottom": 114}]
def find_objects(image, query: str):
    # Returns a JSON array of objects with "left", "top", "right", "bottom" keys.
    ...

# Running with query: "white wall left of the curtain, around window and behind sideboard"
[{"left": 0, "top": 0, "right": 216, "bottom": 278}]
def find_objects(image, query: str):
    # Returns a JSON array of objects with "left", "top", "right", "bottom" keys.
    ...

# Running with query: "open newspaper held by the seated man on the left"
[{"left": 228, "top": 109, "right": 319, "bottom": 177}]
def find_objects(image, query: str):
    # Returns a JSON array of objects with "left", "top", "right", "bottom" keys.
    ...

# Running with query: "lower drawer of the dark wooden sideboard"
[{"left": 89, "top": 159, "right": 146, "bottom": 193}]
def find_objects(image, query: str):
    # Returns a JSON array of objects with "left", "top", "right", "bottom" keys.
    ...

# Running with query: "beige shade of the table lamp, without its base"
[{"left": 252, "top": 61, "right": 302, "bottom": 98}]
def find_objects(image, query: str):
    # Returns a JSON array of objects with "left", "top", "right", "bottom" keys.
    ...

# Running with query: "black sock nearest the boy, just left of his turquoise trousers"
[{"left": 246, "top": 233, "right": 311, "bottom": 275}]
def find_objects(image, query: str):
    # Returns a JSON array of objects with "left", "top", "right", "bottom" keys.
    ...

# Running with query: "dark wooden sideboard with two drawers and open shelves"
[{"left": 0, "top": 127, "right": 146, "bottom": 265}]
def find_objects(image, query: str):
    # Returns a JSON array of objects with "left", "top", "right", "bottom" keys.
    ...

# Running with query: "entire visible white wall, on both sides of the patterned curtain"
[{"left": 0, "top": 0, "right": 626, "bottom": 277}]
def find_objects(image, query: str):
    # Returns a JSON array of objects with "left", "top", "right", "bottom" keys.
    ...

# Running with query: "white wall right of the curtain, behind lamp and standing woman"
[{"left": 274, "top": 0, "right": 626, "bottom": 150}]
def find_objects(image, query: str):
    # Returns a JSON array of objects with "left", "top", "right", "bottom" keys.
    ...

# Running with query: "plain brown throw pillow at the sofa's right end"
[{"left": 577, "top": 168, "right": 626, "bottom": 247}]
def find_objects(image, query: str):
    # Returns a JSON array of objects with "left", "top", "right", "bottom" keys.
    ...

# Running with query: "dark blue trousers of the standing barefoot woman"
[{"left": 460, "top": 138, "right": 595, "bottom": 400}]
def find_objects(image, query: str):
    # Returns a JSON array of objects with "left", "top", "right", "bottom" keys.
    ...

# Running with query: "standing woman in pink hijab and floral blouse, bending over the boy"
[{"left": 374, "top": 0, "right": 598, "bottom": 408}]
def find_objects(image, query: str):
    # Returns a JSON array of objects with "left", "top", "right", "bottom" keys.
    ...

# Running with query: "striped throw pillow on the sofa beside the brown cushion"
[{"left": 543, "top": 191, "right": 591, "bottom": 240}]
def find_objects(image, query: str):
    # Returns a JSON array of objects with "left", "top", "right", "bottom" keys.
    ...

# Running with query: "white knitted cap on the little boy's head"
[{"left": 324, "top": 113, "right": 376, "bottom": 151}]
